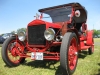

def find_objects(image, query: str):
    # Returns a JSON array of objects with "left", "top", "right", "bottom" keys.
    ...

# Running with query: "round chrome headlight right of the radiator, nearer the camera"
[{"left": 44, "top": 28, "right": 55, "bottom": 41}]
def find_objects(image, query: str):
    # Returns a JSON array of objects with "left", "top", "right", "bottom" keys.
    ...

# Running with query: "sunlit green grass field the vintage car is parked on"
[{"left": 0, "top": 39, "right": 100, "bottom": 75}]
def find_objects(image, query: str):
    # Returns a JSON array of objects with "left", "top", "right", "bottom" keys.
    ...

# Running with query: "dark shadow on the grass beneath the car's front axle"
[{"left": 22, "top": 60, "right": 63, "bottom": 75}]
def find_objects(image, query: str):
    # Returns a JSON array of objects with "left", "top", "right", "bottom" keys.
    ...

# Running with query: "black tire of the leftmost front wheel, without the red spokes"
[{"left": 1, "top": 37, "right": 25, "bottom": 67}]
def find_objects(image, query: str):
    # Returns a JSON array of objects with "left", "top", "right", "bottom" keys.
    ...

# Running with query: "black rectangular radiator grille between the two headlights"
[{"left": 28, "top": 24, "right": 46, "bottom": 45}]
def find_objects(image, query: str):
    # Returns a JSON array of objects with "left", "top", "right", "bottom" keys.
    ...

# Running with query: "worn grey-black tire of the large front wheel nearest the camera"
[{"left": 60, "top": 32, "right": 78, "bottom": 75}]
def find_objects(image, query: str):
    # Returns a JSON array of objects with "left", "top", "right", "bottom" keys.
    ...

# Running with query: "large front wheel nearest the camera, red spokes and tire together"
[{"left": 60, "top": 32, "right": 78, "bottom": 75}]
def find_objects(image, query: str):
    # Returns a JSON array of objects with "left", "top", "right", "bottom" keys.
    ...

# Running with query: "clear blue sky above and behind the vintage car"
[{"left": 0, "top": 0, "right": 100, "bottom": 34}]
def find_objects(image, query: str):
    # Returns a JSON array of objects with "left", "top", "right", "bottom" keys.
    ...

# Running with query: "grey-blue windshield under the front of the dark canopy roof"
[{"left": 44, "top": 6, "right": 72, "bottom": 22}]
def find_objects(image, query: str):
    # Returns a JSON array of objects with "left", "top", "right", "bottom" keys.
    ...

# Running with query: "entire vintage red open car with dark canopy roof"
[{"left": 1, "top": 3, "right": 94, "bottom": 75}]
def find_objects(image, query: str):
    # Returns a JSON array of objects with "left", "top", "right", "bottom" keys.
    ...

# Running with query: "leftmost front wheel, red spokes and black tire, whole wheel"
[{"left": 1, "top": 37, "right": 25, "bottom": 67}]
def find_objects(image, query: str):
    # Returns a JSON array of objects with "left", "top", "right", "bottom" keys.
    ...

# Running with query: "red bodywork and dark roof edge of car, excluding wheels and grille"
[{"left": 16, "top": 4, "right": 94, "bottom": 60}]
